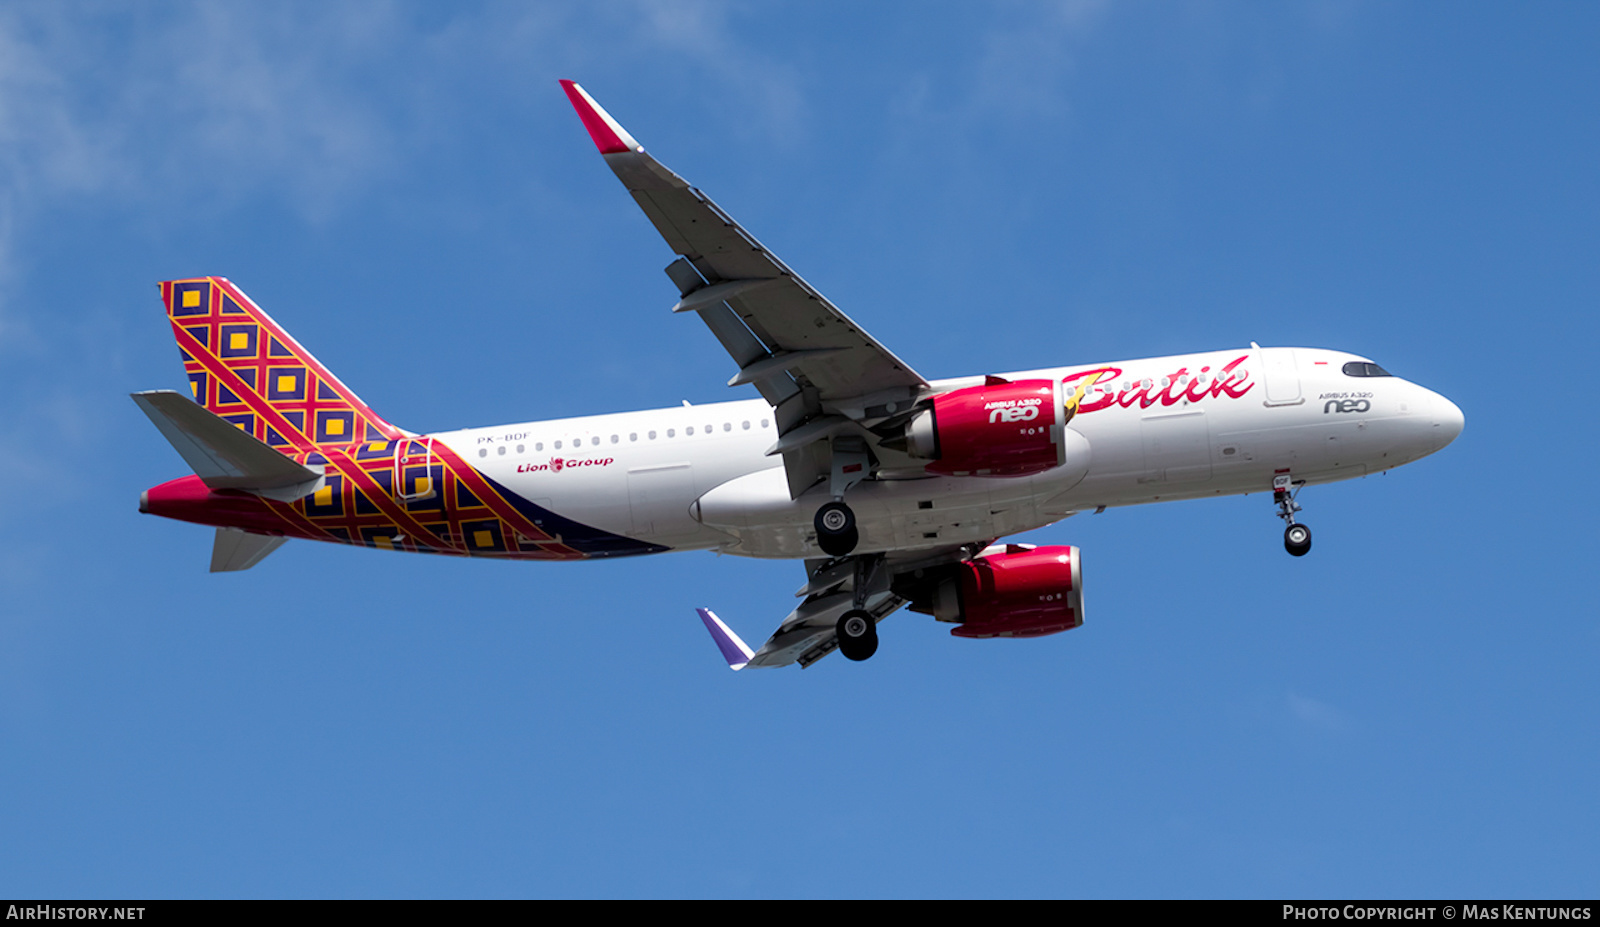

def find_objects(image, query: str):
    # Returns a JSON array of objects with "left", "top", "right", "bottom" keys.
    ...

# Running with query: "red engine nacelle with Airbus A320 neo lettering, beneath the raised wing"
[{"left": 906, "top": 378, "right": 1066, "bottom": 477}]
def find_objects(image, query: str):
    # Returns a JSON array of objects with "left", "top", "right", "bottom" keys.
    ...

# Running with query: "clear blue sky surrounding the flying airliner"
[{"left": 0, "top": 0, "right": 1600, "bottom": 898}]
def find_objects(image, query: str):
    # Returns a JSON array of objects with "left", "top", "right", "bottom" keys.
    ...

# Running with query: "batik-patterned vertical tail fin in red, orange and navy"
[{"left": 162, "top": 277, "right": 405, "bottom": 450}]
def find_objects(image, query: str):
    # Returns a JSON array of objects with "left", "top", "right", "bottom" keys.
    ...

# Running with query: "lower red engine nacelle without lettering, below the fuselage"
[{"left": 933, "top": 544, "right": 1083, "bottom": 637}]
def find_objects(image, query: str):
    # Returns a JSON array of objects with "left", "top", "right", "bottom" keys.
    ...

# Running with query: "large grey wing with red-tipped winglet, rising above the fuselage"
[{"left": 562, "top": 80, "right": 930, "bottom": 495}]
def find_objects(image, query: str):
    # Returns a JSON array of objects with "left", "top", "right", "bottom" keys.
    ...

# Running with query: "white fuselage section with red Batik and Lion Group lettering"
[{"left": 432, "top": 347, "right": 1462, "bottom": 557}]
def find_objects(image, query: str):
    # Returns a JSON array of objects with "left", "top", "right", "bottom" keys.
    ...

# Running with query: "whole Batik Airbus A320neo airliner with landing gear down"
[{"left": 133, "top": 82, "right": 1462, "bottom": 669}]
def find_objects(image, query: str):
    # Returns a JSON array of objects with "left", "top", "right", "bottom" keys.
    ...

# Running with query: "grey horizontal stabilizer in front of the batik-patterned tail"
[{"left": 133, "top": 389, "right": 322, "bottom": 509}]
